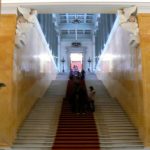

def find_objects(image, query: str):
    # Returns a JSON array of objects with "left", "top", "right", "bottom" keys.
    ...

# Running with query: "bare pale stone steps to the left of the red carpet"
[{"left": 12, "top": 75, "right": 67, "bottom": 150}]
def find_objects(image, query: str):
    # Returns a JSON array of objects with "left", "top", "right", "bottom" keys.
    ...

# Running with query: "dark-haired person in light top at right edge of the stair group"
[{"left": 89, "top": 86, "right": 96, "bottom": 112}]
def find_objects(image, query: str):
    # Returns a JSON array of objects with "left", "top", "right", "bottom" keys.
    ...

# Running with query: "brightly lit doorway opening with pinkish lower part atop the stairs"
[{"left": 70, "top": 53, "right": 83, "bottom": 71}]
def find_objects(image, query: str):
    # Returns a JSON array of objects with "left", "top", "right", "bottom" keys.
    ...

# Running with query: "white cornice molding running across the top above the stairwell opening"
[{"left": 2, "top": 0, "right": 150, "bottom": 14}]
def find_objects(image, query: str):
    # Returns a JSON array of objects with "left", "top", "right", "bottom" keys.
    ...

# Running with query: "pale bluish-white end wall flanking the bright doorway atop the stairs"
[{"left": 60, "top": 40, "right": 94, "bottom": 72}]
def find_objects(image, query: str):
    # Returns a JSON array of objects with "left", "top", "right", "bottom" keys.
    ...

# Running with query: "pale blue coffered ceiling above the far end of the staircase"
[{"left": 53, "top": 13, "right": 100, "bottom": 40}]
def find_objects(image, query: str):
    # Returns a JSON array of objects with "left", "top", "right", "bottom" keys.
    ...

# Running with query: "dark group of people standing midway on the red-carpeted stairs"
[{"left": 69, "top": 73, "right": 96, "bottom": 114}]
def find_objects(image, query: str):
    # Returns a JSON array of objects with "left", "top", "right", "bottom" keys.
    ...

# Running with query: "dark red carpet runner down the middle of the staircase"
[{"left": 52, "top": 81, "right": 100, "bottom": 150}]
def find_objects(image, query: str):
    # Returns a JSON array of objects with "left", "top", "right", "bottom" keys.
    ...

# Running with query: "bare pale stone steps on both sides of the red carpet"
[{"left": 12, "top": 74, "right": 144, "bottom": 150}]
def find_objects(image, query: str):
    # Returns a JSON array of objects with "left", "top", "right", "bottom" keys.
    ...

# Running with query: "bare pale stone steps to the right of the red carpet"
[{"left": 86, "top": 74, "right": 144, "bottom": 150}]
